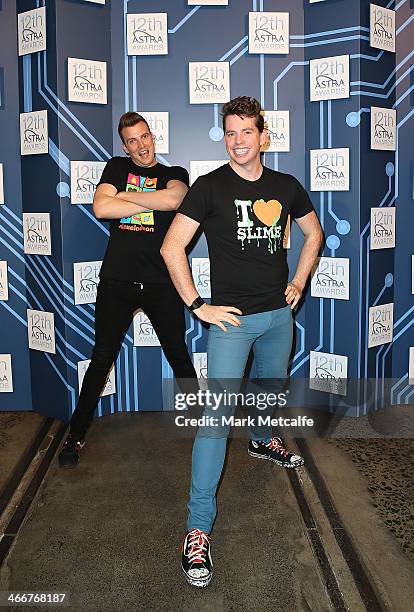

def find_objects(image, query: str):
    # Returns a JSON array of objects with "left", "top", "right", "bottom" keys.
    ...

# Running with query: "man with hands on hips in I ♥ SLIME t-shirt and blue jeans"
[{"left": 161, "top": 96, "right": 322, "bottom": 587}]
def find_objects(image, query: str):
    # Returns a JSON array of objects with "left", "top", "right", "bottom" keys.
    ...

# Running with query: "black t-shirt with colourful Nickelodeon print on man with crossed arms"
[{"left": 99, "top": 157, "right": 189, "bottom": 283}]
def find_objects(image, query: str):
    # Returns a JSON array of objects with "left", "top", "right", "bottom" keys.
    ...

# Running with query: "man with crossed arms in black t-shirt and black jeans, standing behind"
[{"left": 59, "top": 112, "right": 196, "bottom": 467}]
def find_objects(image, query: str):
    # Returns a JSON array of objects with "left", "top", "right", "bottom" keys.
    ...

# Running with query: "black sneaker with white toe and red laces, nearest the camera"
[{"left": 181, "top": 529, "right": 213, "bottom": 587}]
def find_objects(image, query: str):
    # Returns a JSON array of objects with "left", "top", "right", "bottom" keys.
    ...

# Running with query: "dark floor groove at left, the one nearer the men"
[{"left": 4, "top": 424, "right": 67, "bottom": 537}]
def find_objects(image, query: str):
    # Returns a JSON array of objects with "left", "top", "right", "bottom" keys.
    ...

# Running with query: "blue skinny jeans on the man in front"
[{"left": 187, "top": 306, "right": 293, "bottom": 533}]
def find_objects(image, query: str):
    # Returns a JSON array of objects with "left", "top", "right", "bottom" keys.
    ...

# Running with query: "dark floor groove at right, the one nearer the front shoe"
[{"left": 287, "top": 470, "right": 348, "bottom": 612}]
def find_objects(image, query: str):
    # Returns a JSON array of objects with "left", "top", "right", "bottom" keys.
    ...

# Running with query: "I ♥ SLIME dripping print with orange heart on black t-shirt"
[{"left": 234, "top": 199, "right": 283, "bottom": 253}]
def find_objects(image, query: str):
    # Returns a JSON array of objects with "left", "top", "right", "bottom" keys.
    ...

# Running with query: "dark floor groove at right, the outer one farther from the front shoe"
[{"left": 295, "top": 438, "right": 386, "bottom": 612}]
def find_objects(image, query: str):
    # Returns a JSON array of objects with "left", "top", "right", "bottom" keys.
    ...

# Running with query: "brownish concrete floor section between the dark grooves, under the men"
[{"left": 0, "top": 413, "right": 331, "bottom": 612}]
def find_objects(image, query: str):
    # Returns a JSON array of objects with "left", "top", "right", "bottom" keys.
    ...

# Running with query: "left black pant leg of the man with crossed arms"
[{"left": 70, "top": 279, "right": 139, "bottom": 437}]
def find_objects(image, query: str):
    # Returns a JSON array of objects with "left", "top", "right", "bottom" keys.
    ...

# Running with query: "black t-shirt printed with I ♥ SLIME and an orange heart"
[{"left": 179, "top": 164, "right": 314, "bottom": 315}]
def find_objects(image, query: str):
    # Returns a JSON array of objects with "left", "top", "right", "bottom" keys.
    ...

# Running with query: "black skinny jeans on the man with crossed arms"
[{"left": 70, "top": 279, "right": 198, "bottom": 438}]
